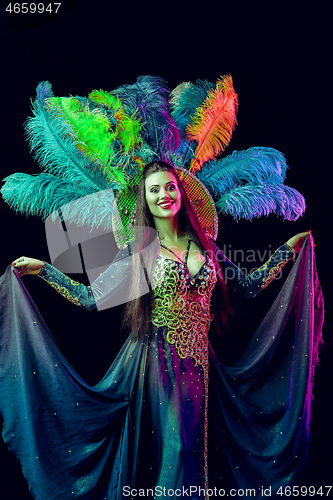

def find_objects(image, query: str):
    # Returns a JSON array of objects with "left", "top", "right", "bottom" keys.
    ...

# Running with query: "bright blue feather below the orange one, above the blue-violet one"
[{"left": 197, "top": 147, "right": 287, "bottom": 199}]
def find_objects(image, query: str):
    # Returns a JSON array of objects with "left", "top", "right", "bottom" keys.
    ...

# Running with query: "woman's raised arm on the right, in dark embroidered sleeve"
[{"left": 216, "top": 231, "right": 310, "bottom": 297}]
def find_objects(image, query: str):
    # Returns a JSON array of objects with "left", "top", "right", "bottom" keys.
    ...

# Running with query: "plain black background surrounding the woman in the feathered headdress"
[{"left": 0, "top": 0, "right": 332, "bottom": 500}]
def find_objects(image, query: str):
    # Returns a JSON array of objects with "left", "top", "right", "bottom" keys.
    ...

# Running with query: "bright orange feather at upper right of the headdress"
[{"left": 186, "top": 75, "right": 238, "bottom": 171}]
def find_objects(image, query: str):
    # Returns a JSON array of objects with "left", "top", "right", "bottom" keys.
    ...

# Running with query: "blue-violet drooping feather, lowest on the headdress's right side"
[{"left": 216, "top": 184, "right": 306, "bottom": 221}]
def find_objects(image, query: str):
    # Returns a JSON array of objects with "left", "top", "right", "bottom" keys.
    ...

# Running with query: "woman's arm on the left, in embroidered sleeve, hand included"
[{"left": 12, "top": 245, "right": 132, "bottom": 310}]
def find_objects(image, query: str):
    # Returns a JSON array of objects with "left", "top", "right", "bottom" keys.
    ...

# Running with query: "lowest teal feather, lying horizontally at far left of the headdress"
[{"left": 1, "top": 173, "right": 114, "bottom": 228}]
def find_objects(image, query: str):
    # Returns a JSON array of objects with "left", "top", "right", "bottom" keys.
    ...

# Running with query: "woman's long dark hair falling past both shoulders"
[{"left": 123, "top": 161, "right": 232, "bottom": 336}]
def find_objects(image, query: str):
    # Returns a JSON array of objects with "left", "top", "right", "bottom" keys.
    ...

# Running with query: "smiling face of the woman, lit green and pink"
[{"left": 145, "top": 171, "right": 182, "bottom": 218}]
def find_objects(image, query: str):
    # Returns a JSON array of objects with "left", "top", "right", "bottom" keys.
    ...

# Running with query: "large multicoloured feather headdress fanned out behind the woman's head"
[{"left": 1, "top": 75, "right": 305, "bottom": 247}]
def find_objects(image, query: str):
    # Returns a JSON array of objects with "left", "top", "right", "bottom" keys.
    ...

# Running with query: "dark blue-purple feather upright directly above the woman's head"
[{"left": 111, "top": 75, "right": 180, "bottom": 158}]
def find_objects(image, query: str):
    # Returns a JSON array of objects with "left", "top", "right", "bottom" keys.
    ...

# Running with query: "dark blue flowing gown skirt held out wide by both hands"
[{"left": 0, "top": 238, "right": 323, "bottom": 500}]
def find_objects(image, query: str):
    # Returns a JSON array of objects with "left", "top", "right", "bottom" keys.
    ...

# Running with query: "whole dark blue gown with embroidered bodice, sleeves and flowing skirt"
[{"left": 0, "top": 237, "right": 318, "bottom": 500}]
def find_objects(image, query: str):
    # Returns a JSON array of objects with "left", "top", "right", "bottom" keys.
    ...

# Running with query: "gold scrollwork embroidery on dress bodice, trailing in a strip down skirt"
[{"left": 152, "top": 259, "right": 216, "bottom": 491}]
